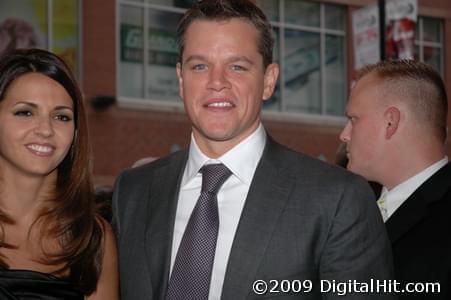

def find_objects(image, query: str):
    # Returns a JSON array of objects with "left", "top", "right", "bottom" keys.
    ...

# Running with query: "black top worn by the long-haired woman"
[{"left": 0, "top": 268, "right": 85, "bottom": 300}]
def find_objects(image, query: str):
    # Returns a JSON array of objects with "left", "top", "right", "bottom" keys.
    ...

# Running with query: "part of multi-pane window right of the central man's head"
[{"left": 257, "top": 0, "right": 347, "bottom": 116}]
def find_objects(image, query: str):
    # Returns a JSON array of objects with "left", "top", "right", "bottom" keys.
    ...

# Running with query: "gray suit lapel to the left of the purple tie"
[{"left": 143, "top": 152, "right": 187, "bottom": 299}]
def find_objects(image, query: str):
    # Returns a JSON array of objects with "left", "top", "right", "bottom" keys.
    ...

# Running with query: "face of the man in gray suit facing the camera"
[{"left": 177, "top": 19, "right": 278, "bottom": 155}]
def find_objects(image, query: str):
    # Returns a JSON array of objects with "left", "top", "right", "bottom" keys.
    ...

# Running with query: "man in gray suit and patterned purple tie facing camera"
[{"left": 113, "top": 0, "right": 392, "bottom": 300}]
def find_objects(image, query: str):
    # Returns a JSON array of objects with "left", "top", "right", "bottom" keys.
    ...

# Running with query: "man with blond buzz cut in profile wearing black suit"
[{"left": 340, "top": 60, "right": 451, "bottom": 299}]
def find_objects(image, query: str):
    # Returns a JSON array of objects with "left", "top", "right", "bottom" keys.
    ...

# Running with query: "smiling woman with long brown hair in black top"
[{"left": 0, "top": 49, "right": 118, "bottom": 300}]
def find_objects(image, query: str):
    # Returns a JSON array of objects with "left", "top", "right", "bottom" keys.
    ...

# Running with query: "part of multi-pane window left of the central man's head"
[{"left": 118, "top": 0, "right": 185, "bottom": 103}]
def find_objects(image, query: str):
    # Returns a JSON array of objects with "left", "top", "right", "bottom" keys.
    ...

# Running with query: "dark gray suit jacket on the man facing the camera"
[{"left": 113, "top": 137, "right": 392, "bottom": 300}]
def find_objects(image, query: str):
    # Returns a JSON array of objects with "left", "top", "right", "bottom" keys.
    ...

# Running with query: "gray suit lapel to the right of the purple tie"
[{"left": 221, "top": 137, "right": 294, "bottom": 299}]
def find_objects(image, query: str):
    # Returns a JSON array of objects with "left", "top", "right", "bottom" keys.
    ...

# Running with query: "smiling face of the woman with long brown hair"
[{"left": 0, "top": 73, "right": 75, "bottom": 176}]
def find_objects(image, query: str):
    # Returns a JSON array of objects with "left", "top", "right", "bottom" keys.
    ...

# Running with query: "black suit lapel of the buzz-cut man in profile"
[{"left": 386, "top": 163, "right": 451, "bottom": 244}]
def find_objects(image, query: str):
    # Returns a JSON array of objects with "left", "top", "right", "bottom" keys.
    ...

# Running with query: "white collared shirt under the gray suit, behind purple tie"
[{"left": 171, "top": 124, "right": 266, "bottom": 300}]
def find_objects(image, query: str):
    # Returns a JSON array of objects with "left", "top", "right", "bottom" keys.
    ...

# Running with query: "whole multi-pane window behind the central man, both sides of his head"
[{"left": 118, "top": 0, "right": 347, "bottom": 116}]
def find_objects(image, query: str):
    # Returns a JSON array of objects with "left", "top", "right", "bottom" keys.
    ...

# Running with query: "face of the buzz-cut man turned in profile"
[{"left": 340, "top": 74, "right": 387, "bottom": 180}]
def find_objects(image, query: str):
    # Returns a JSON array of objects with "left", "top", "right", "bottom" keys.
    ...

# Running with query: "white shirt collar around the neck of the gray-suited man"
[{"left": 182, "top": 123, "right": 266, "bottom": 187}]
